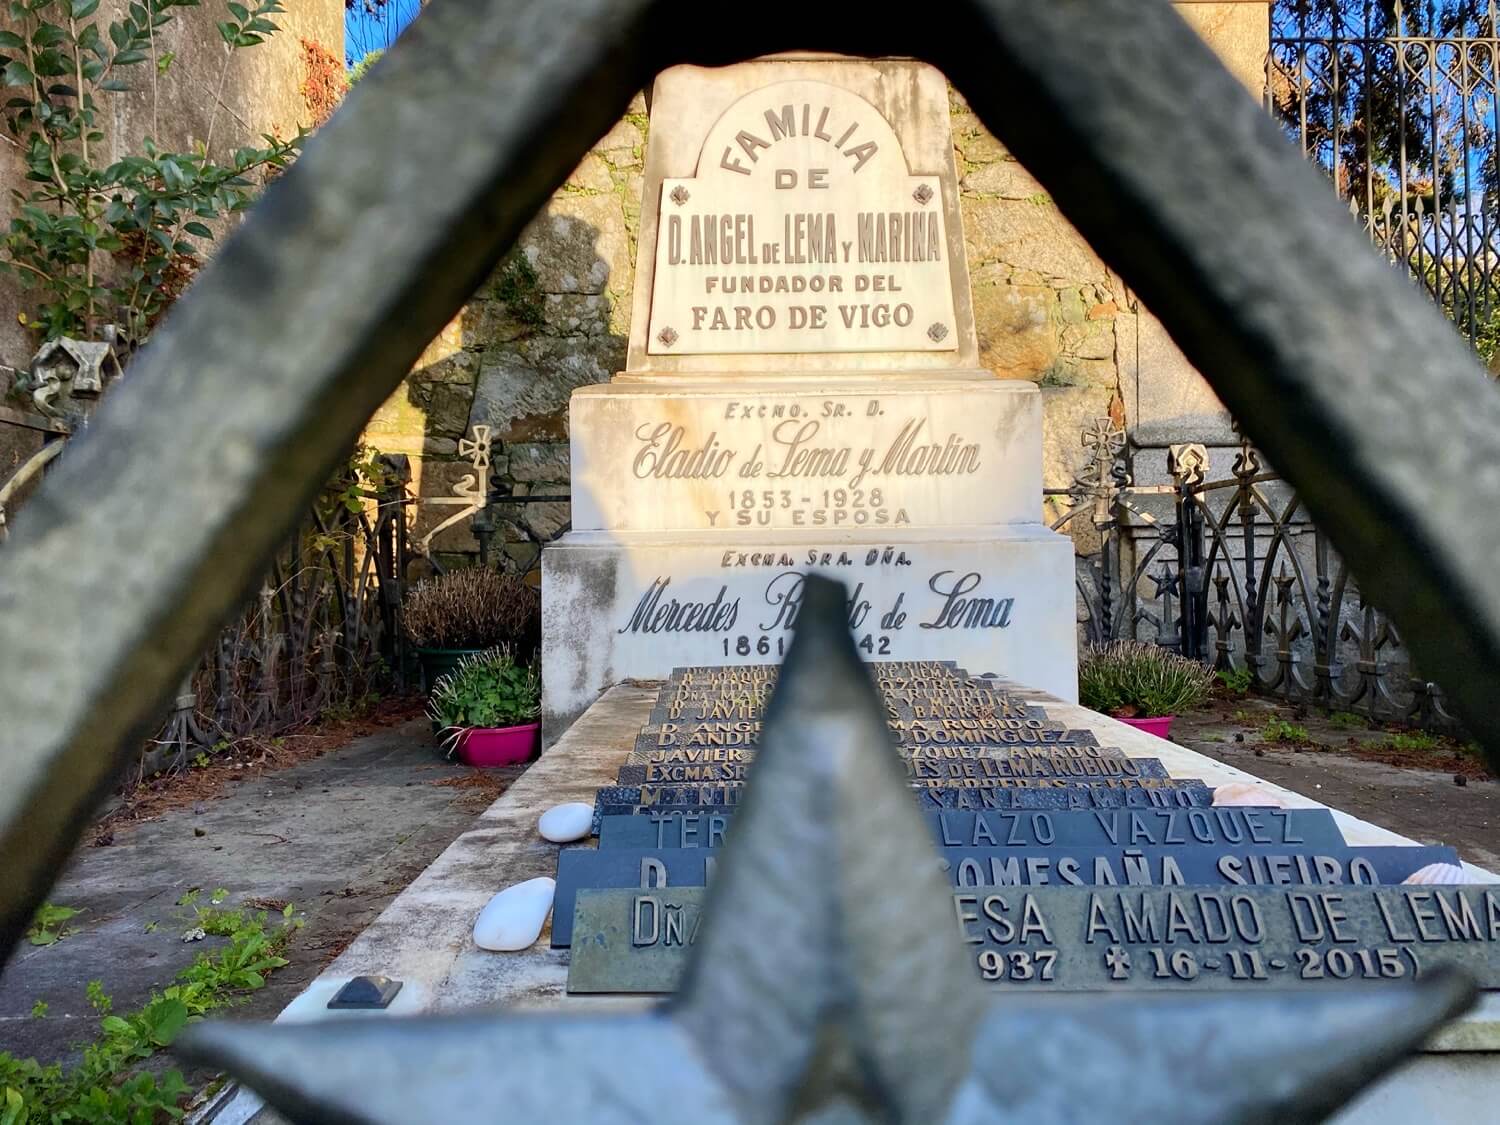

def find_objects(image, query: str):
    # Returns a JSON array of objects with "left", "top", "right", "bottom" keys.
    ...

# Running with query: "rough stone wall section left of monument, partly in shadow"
[{"left": 375, "top": 98, "right": 647, "bottom": 570}]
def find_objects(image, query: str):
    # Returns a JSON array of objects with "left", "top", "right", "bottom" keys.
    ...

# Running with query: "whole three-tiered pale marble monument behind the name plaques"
[{"left": 543, "top": 59, "right": 1077, "bottom": 746}]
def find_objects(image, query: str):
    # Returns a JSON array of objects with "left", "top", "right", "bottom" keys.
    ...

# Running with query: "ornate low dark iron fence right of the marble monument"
[{"left": 1047, "top": 420, "right": 1457, "bottom": 729}]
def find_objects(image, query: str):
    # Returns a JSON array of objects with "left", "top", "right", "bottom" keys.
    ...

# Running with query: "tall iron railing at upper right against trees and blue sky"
[{"left": 1266, "top": 0, "right": 1500, "bottom": 352}]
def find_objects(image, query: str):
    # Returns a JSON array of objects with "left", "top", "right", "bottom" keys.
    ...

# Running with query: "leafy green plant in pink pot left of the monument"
[{"left": 428, "top": 645, "right": 542, "bottom": 767}]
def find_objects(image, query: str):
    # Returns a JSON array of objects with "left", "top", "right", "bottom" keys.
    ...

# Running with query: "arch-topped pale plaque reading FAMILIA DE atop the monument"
[{"left": 647, "top": 80, "right": 957, "bottom": 356}]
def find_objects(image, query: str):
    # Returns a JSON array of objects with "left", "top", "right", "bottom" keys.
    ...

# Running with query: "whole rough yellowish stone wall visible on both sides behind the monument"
[{"left": 366, "top": 0, "right": 1269, "bottom": 570}]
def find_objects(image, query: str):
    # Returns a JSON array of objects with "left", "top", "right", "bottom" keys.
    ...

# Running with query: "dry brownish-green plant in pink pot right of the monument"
[{"left": 1079, "top": 641, "right": 1214, "bottom": 738}]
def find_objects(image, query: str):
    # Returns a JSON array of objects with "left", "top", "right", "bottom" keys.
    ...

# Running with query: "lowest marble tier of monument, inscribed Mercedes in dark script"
[{"left": 542, "top": 528, "right": 1079, "bottom": 719}]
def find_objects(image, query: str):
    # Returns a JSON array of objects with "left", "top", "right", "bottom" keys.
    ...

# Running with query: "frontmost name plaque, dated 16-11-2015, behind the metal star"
[{"left": 567, "top": 885, "right": 1500, "bottom": 993}]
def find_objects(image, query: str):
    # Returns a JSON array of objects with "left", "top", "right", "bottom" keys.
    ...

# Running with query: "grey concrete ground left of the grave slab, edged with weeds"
[{"left": 0, "top": 720, "right": 519, "bottom": 1062}]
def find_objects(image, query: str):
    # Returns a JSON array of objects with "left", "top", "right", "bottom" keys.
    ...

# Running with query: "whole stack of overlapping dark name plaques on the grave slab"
[{"left": 552, "top": 662, "right": 1500, "bottom": 995}]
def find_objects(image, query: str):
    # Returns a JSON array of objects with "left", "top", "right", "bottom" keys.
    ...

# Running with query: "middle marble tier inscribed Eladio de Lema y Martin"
[{"left": 572, "top": 380, "right": 1043, "bottom": 536}]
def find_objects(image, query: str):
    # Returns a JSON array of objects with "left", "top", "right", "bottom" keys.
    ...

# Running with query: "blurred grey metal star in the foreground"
[{"left": 180, "top": 578, "right": 1473, "bottom": 1125}]
